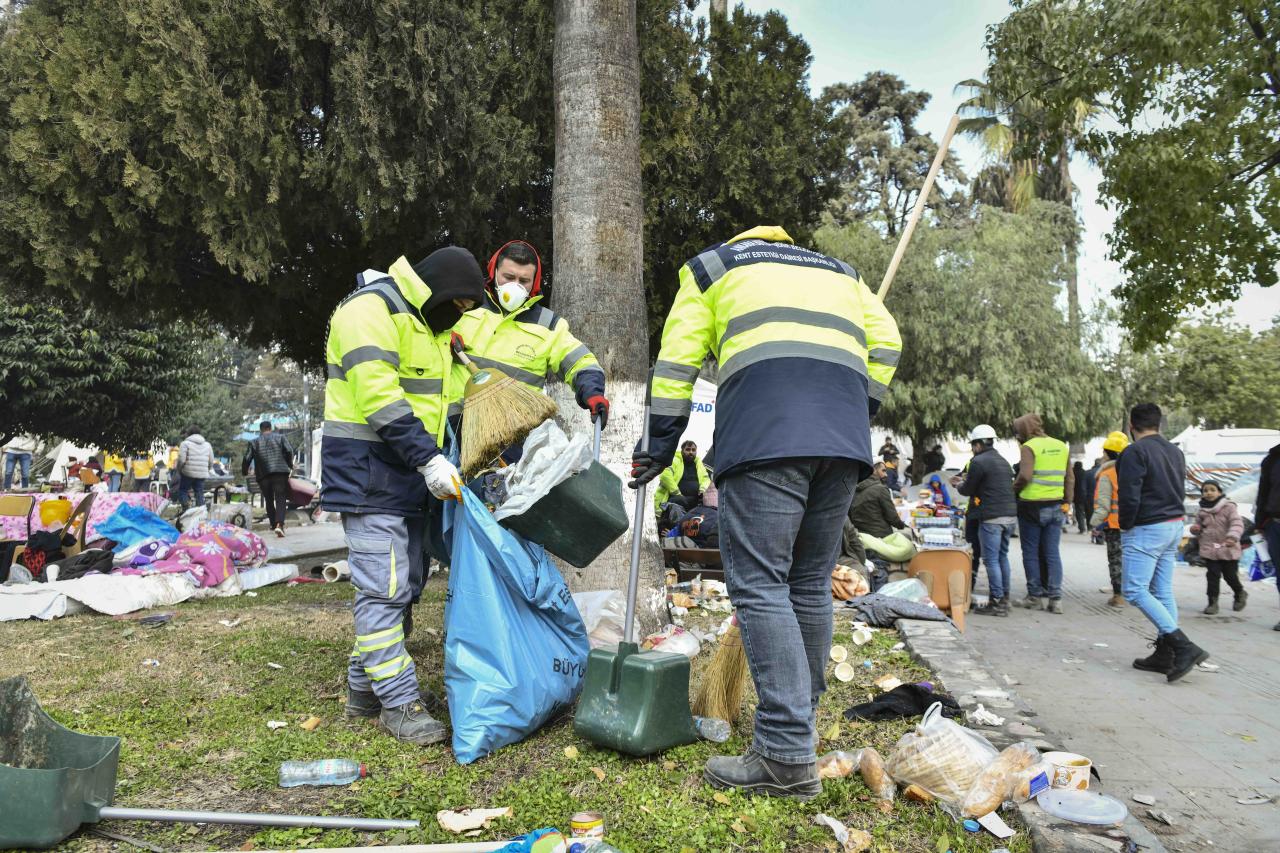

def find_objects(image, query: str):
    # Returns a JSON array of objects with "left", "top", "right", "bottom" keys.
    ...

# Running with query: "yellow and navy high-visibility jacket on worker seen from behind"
[{"left": 650, "top": 225, "right": 902, "bottom": 479}]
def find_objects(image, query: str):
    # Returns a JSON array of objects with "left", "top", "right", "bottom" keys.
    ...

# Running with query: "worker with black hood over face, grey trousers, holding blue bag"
[{"left": 320, "top": 246, "right": 484, "bottom": 744}]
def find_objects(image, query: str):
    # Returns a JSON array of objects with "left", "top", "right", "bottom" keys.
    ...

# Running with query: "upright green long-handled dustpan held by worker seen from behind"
[{"left": 573, "top": 401, "right": 698, "bottom": 756}]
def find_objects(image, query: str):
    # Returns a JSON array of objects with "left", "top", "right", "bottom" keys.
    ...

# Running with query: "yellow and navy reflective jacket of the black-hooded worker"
[{"left": 320, "top": 257, "right": 461, "bottom": 515}]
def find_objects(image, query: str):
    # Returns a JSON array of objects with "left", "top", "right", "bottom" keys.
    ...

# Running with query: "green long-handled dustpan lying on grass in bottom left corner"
[{"left": 0, "top": 676, "right": 417, "bottom": 850}]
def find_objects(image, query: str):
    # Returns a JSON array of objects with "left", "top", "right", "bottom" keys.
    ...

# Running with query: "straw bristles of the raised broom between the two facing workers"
[{"left": 462, "top": 371, "right": 556, "bottom": 476}]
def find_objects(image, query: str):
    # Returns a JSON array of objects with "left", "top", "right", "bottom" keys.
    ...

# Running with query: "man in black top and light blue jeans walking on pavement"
[{"left": 1116, "top": 403, "right": 1208, "bottom": 681}]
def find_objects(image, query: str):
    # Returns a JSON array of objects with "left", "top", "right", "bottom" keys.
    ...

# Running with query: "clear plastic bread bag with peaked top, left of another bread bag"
[{"left": 886, "top": 702, "right": 998, "bottom": 809}]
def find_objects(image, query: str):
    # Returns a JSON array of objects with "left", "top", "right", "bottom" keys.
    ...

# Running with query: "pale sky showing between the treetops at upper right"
[{"left": 737, "top": 0, "right": 1280, "bottom": 329}]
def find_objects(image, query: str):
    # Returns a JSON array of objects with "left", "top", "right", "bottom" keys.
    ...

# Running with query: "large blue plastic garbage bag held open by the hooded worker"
[{"left": 444, "top": 489, "right": 590, "bottom": 765}]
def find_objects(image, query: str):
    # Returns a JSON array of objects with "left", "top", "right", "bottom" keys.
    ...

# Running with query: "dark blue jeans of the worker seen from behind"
[{"left": 719, "top": 459, "right": 860, "bottom": 765}]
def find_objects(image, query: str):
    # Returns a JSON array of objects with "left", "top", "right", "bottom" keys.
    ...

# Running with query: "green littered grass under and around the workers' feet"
[{"left": 0, "top": 578, "right": 1030, "bottom": 853}]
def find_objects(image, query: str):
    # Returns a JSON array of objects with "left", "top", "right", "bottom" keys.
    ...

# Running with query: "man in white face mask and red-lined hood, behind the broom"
[{"left": 452, "top": 240, "right": 609, "bottom": 462}]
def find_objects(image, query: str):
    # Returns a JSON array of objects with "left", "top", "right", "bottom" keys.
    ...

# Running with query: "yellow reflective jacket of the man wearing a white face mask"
[{"left": 453, "top": 291, "right": 604, "bottom": 409}]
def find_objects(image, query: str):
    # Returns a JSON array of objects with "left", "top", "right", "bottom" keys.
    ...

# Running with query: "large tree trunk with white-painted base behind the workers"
[{"left": 552, "top": 0, "right": 662, "bottom": 615}]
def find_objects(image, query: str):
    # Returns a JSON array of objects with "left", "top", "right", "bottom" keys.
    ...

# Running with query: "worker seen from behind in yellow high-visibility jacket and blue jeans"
[{"left": 631, "top": 225, "right": 902, "bottom": 799}]
